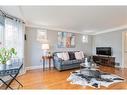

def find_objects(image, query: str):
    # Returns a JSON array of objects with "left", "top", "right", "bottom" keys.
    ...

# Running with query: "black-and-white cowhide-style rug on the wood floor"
[{"left": 67, "top": 69, "right": 124, "bottom": 88}]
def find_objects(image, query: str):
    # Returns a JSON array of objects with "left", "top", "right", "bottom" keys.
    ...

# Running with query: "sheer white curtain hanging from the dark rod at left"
[{"left": 4, "top": 18, "right": 25, "bottom": 62}]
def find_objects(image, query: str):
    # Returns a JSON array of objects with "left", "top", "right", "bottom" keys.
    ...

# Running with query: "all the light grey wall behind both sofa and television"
[{"left": 25, "top": 27, "right": 127, "bottom": 67}]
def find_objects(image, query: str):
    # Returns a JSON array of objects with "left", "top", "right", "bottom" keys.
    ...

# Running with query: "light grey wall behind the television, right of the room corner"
[{"left": 93, "top": 30, "right": 126, "bottom": 66}]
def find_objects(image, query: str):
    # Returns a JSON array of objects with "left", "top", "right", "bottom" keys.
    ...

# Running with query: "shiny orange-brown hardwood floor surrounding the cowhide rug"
[{"left": 1, "top": 66, "right": 127, "bottom": 90}]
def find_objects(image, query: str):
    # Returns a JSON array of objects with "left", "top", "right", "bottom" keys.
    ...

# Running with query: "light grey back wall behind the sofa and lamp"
[{"left": 26, "top": 27, "right": 92, "bottom": 67}]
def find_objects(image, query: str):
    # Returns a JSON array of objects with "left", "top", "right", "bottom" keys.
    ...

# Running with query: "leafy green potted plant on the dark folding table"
[{"left": 0, "top": 48, "right": 17, "bottom": 70}]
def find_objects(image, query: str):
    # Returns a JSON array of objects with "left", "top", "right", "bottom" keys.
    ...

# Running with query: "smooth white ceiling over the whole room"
[{"left": 0, "top": 6, "right": 127, "bottom": 34}]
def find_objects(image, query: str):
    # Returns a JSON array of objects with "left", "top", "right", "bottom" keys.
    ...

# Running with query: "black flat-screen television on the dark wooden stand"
[{"left": 96, "top": 47, "right": 112, "bottom": 56}]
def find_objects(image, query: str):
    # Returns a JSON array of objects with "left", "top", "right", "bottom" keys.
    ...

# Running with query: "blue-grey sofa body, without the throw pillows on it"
[{"left": 53, "top": 51, "right": 85, "bottom": 71}]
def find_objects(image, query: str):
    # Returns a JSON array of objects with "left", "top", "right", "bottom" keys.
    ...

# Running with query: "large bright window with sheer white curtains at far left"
[{"left": 0, "top": 16, "right": 25, "bottom": 59}]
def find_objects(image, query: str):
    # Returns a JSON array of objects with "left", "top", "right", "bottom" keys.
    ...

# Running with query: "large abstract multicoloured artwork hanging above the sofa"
[{"left": 58, "top": 32, "right": 76, "bottom": 48}]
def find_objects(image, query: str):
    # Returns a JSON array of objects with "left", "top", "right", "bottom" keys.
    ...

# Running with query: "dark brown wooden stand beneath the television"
[{"left": 93, "top": 55, "right": 115, "bottom": 67}]
